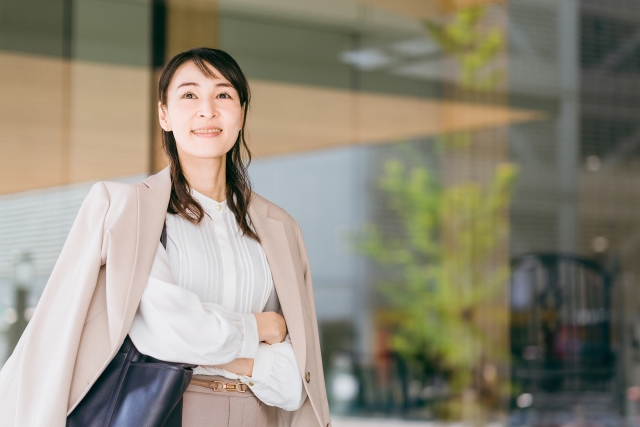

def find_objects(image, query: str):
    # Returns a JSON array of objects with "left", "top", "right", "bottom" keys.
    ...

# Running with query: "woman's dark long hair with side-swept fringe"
[{"left": 158, "top": 47, "right": 260, "bottom": 242}]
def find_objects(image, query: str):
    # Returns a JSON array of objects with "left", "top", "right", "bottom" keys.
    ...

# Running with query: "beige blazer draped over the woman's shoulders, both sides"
[{"left": 0, "top": 168, "right": 330, "bottom": 427}]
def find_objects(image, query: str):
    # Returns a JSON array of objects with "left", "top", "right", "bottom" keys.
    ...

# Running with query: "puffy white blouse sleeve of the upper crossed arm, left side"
[{"left": 129, "top": 243, "right": 258, "bottom": 365}]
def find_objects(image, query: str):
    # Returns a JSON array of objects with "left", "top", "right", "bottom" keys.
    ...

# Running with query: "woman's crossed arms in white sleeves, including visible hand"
[{"left": 129, "top": 244, "right": 306, "bottom": 411}]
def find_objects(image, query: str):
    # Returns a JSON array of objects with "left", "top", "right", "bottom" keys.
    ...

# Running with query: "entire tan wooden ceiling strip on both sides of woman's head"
[{"left": 0, "top": 53, "right": 543, "bottom": 193}]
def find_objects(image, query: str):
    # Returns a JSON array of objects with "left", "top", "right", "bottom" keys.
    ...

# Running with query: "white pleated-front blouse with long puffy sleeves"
[{"left": 129, "top": 190, "right": 306, "bottom": 411}]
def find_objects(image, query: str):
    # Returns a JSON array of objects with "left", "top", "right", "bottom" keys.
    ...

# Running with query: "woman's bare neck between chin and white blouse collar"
[{"left": 180, "top": 154, "right": 227, "bottom": 202}]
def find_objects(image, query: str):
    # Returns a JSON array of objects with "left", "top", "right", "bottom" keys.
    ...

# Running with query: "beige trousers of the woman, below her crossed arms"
[{"left": 182, "top": 375, "right": 278, "bottom": 427}]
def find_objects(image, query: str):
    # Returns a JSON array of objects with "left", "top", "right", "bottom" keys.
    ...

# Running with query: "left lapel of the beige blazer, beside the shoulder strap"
[{"left": 114, "top": 167, "right": 171, "bottom": 341}]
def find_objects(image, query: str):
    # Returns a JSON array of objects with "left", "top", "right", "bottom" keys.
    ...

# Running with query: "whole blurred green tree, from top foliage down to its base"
[{"left": 356, "top": 6, "right": 517, "bottom": 424}]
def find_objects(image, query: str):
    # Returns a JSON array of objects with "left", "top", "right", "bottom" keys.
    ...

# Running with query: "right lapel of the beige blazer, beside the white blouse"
[{"left": 250, "top": 202, "right": 307, "bottom": 375}]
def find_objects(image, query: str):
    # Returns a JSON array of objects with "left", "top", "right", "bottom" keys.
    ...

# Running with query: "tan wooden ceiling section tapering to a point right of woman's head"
[{"left": 248, "top": 80, "right": 544, "bottom": 157}]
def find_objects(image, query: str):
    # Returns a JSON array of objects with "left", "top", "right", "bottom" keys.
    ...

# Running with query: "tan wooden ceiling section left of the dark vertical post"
[{"left": 0, "top": 52, "right": 151, "bottom": 194}]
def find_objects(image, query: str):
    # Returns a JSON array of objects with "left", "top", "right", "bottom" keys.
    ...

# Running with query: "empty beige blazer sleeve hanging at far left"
[{"left": 0, "top": 182, "right": 110, "bottom": 427}]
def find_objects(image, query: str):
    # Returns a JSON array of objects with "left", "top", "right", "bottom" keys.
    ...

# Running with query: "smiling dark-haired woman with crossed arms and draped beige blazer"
[{"left": 0, "top": 48, "right": 330, "bottom": 427}]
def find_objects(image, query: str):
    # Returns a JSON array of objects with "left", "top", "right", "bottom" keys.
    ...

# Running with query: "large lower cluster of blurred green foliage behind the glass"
[{"left": 357, "top": 160, "right": 516, "bottom": 390}]
